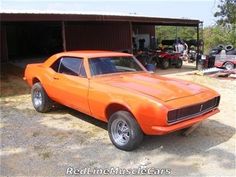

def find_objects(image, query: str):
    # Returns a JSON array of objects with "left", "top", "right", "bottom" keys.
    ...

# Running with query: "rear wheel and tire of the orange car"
[{"left": 31, "top": 82, "right": 52, "bottom": 113}]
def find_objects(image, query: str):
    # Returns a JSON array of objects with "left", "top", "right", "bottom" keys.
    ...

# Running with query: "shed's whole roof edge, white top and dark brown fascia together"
[{"left": 0, "top": 10, "right": 201, "bottom": 26}]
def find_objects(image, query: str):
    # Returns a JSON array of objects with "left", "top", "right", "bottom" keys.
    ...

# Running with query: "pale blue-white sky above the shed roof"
[{"left": 0, "top": 0, "right": 219, "bottom": 27}]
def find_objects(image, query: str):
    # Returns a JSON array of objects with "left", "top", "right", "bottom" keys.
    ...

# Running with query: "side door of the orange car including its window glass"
[{"left": 50, "top": 57, "right": 90, "bottom": 114}]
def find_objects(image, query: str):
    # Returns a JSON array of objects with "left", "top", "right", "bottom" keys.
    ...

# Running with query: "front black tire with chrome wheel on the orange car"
[{"left": 108, "top": 111, "right": 143, "bottom": 151}]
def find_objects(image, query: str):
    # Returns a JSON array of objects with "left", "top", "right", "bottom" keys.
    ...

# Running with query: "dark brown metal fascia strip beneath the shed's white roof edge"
[{"left": 0, "top": 12, "right": 201, "bottom": 27}]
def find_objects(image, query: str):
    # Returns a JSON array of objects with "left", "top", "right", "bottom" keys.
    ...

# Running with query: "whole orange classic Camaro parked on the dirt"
[{"left": 24, "top": 51, "right": 220, "bottom": 150}]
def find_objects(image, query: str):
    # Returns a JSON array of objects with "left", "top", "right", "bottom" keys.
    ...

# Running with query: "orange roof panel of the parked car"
[{"left": 57, "top": 50, "right": 132, "bottom": 58}]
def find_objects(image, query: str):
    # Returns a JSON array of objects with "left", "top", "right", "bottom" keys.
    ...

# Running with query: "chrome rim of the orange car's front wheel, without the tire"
[{"left": 111, "top": 118, "right": 130, "bottom": 146}]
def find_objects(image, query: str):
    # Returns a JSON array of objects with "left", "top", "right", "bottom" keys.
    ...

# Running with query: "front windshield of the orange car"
[{"left": 89, "top": 57, "right": 144, "bottom": 76}]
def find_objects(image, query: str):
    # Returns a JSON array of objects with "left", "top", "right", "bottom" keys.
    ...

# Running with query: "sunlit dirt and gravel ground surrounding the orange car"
[{"left": 0, "top": 64, "right": 236, "bottom": 176}]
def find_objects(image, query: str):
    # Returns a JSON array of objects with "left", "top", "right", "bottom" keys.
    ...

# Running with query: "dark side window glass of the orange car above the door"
[{"left": 51, "top": 57, "right": 86, "bottom": 77}]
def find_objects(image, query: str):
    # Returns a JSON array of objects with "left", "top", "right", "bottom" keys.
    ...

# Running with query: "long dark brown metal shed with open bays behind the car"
[{"left": 0, "top": 11, "right": 202, "bottom": 62}]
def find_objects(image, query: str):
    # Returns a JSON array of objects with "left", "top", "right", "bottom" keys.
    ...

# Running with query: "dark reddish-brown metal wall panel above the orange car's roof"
[{"left": 65, "top": 22, "right": 131, "bottom": 50}]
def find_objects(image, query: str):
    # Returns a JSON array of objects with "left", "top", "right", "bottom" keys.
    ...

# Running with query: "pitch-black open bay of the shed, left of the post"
[{"left": 6, "top": 22, "right": 63, "bottom": 61}]
